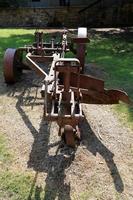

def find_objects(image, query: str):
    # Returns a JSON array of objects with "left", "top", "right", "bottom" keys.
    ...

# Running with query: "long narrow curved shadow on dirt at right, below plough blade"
[{"left": 80, "top": 115, "right": 124, "bottom": 193}]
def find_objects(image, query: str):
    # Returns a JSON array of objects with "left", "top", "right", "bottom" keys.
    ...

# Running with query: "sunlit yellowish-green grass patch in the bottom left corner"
[{"left": 0, "top": 133, "right": 34, "bottom": 200}]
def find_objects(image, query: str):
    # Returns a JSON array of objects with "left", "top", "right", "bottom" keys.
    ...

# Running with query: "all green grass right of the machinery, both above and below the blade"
[{"left": 86, "top": 34, "right": 133, "bottom": 129}]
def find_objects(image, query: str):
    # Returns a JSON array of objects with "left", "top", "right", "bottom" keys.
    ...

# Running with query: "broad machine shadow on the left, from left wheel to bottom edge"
[{"left": 7, "top": 75, "right": 75, "bottom": 200}]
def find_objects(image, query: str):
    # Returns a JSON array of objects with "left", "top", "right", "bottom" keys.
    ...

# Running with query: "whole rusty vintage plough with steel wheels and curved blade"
[{"left": 4, "top": 28, "right": 129, "bottom": 147}]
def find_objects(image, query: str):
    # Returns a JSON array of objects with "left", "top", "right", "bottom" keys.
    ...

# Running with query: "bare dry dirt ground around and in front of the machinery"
[{"left": 0, "top": 63, "right": 133, "bottom": 200}]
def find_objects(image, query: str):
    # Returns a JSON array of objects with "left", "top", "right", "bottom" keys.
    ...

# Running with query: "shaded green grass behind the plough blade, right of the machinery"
[{"left": 87, "top": 33, "right": 133, "bottom": 91}]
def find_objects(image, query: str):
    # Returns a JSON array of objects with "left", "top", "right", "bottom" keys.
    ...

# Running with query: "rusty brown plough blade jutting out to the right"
[{"left": 71, "top": 73, "right": 131, "bottom": 104}]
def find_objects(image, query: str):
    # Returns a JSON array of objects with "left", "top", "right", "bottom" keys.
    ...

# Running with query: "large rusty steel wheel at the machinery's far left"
[{"left": 3, "top": 49, "right": 22, "bottom": 84}]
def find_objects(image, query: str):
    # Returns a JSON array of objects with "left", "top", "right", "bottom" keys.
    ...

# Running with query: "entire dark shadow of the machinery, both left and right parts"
[{"left": 5, "top": 69, "right": 124, "bottom": 200}]
